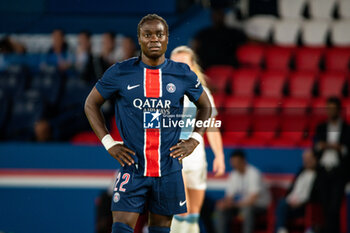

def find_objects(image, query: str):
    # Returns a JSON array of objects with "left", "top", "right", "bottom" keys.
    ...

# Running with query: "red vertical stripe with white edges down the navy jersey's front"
[{"left": 144, "top": 69, "right": 161, "bottom": 177}]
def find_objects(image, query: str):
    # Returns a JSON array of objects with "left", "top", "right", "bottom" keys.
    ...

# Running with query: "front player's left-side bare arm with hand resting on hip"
[{"left": 84, "top": 87, "right": 135, "bottom": 166}]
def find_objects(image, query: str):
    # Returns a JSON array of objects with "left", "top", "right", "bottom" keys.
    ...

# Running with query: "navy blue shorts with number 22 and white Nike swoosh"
[{"left": 111, "top": 166, "right": 187, "bottom": 216}]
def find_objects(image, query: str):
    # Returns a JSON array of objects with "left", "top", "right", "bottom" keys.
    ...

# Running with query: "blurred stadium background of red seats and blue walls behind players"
[{"left": 0, "top": 0, "right": 350, "bottom": 233}]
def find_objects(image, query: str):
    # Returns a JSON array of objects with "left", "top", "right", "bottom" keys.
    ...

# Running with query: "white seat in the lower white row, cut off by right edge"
[{"left": 331, "top": 19, "right": 350, "bottom": 47}]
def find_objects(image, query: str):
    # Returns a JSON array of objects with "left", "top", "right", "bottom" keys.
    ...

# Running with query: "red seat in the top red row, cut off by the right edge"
[{"left": 325, "top": 47, "right": 350, "bottom": 72}]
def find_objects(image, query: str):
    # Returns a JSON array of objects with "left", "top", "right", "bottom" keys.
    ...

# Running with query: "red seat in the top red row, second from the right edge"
[{"left": 294, "top": 47, "right": 325, "bottom": 72}]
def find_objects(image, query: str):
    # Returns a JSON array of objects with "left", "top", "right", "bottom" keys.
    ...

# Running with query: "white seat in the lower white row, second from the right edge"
[{"left": 301, "top": 20, "right": 330, "bottom": 46}]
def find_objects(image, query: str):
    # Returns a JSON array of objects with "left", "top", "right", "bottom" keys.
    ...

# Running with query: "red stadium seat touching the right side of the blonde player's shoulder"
[{"left": 205, "top": 65, "right": 233, "bottom": 93}]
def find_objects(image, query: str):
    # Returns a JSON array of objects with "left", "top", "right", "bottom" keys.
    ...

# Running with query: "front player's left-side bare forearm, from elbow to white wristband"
[{"left": 84, "top": 91, "right": 108, "bottom": 140}]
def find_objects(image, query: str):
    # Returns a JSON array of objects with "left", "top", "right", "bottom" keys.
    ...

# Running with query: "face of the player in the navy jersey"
[{"left": 138, "top": 20, "right": 168, "bottom": 59}]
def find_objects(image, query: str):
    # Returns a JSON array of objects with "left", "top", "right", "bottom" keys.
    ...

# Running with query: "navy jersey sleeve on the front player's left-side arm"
[{"left": 95, "top": 64, "right": 119, "bottom": 99}]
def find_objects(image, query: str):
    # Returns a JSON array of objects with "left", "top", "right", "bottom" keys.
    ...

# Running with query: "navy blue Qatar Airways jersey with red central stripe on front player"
[{"left": 96, "top": 58, "right": 203, "bottom": 177}]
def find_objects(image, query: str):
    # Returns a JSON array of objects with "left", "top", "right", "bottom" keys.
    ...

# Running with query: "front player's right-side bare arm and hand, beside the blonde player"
[{"left": 170, "top": 91, "right": 211, "bottom": 160}]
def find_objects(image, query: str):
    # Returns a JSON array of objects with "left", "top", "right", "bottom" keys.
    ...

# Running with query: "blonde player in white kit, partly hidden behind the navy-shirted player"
[{"left": 170, "top": 46, "right": 225, "bottom": 233}]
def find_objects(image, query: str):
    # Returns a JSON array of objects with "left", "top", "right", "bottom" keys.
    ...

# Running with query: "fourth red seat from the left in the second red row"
[{"left": 289, "top": 71, "right": 316, "bottom": 98}]
